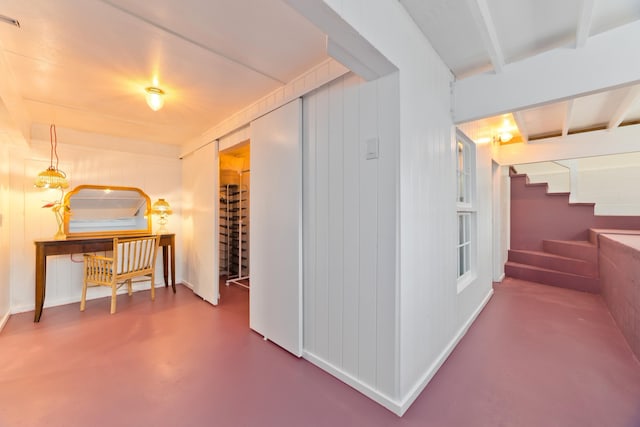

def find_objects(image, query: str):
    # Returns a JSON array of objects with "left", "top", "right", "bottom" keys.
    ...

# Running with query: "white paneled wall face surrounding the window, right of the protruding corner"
[{"left": 316, "top": 0, "right": 491, "bottom": 414}]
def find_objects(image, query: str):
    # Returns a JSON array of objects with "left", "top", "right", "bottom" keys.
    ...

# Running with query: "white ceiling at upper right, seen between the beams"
[{"left": 400, "top": 0, "right": 640, "bottom": 144}]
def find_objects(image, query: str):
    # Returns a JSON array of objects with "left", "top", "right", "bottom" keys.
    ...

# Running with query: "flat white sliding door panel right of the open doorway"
[{"left": 249, "top": 99, "right": 302, "bottom": 357}]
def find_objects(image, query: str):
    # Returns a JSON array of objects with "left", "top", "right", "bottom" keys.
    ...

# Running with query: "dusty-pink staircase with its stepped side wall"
[{"left": 505, "top": 169, "right": 640, "bottom": 293}]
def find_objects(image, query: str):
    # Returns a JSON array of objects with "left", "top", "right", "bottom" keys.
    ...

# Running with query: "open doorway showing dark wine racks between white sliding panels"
[{"left": 218, "top": 140, "right": 251, "bottom": 289}]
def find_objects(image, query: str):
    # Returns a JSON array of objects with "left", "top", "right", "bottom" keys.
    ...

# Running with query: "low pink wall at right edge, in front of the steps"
[{"left": 599, "top": 234, "right": 640, "bottom": 359}]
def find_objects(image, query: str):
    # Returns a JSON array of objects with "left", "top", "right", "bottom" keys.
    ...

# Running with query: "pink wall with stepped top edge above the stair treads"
[{"left": 511, "top": 175, "right": 640, "bottom": 251}]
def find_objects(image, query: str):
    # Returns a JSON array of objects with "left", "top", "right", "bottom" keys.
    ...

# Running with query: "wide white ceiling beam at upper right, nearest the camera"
[{"left": 453, "top": 21, "right": 640, "bottom": 123}]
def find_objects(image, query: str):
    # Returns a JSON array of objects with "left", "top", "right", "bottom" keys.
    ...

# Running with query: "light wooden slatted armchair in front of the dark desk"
[{"left": 80, "top": 236, "right": 160, "bottom": 314}]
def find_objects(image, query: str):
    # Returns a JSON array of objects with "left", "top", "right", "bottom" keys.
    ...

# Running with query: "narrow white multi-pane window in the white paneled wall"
[{"left": 456, "top": 131, "right": 477, "bottom": 284}]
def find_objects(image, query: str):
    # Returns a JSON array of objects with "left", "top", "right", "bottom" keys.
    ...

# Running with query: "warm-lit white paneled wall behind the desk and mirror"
[{"left": 9, "top": 137, "right": 182, "bottom": 317}]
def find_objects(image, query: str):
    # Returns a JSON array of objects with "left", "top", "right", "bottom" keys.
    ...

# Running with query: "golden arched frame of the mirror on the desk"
[{"left": 63, "top": 184, "right": 152, "bottom": 238}]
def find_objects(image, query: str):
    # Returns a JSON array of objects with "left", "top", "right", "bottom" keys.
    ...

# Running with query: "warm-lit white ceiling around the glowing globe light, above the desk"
[{"left": 0, "top": 0, "right": 327, "bottom": 144}]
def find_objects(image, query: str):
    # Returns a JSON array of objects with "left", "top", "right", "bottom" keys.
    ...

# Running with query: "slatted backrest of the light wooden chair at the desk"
[{"left": 113, "top": 236, "right": 160, "bottom": 275}]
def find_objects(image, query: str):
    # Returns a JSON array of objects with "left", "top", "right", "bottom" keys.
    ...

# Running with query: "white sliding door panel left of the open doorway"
[{"left": 183, "top": 142, "right": 220, "bottom": 305}]
